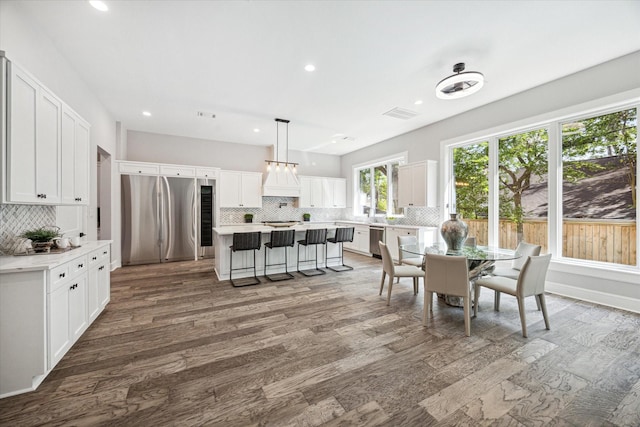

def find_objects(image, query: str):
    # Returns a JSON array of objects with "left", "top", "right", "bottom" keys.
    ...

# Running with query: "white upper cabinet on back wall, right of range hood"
[{"left": 298, "top": 176, "right": 347, "bottom": 208}]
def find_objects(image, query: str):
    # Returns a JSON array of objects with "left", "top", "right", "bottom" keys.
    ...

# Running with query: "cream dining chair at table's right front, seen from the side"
[{"left": 473, "top": 254, "right": 551, "bottom": 338}]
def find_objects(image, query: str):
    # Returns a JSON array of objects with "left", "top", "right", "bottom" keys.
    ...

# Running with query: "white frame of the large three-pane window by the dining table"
[{"left": 440, "top": 90, "right": 640, "bottom": 280}]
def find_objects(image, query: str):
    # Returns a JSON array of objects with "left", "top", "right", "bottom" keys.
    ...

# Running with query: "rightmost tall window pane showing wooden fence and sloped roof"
[{"left": 562, "top": 108, "right": 638, "bottom": 265}]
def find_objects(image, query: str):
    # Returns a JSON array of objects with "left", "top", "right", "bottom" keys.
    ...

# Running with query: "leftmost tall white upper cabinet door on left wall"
[{"left": 7, "top": 65, "right": 39, "bottom": 202}]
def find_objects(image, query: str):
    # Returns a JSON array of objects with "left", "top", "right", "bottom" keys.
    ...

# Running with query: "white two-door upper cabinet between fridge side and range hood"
[{"left": 219, "top": 171, "right": 262, "bottom": 208}]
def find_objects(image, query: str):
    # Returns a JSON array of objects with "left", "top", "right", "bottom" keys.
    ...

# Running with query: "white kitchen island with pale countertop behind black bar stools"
[{"left": 213, "top": 222, "right": 339, "bottom": 280}]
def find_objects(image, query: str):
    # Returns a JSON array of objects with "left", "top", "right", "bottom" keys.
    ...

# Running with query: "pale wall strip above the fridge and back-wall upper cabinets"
[{"left": 127, "top": 130, "right": 341, "bottom": 177}]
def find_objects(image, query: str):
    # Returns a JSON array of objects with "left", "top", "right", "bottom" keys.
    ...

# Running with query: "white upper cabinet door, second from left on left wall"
[{"left": 36, "top": 88, "right": 62, "bottom": 204}]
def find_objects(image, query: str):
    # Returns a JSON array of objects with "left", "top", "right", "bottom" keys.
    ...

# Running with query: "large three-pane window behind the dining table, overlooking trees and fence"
[{"left": 448, "top": 106, "right": 640, "bottom": 268}]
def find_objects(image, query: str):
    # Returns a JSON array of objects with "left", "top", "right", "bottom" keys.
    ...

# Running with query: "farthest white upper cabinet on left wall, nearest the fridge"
[{"left": 60, "top": 105, "right": 90, "bottom": 205}]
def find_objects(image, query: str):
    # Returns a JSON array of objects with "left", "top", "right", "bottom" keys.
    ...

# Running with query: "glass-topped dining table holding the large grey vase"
[{"left": 400, "top": 242, "right": 522, "bottom": 307}]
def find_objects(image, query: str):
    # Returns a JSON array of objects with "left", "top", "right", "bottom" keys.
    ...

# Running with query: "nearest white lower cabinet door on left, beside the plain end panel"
[{"left": 48, "top": 285, "right": 71, "bottom": 369}]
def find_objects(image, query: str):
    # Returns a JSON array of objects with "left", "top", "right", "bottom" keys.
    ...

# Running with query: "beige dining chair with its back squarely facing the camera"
[{"left": 422, "top": 253, "right": 471, "bottom": 336}]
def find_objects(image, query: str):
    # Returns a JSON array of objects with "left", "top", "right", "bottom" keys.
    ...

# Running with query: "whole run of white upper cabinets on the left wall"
[{"left": 2, "top": 60, "right": 90, "bottom": 205}]
